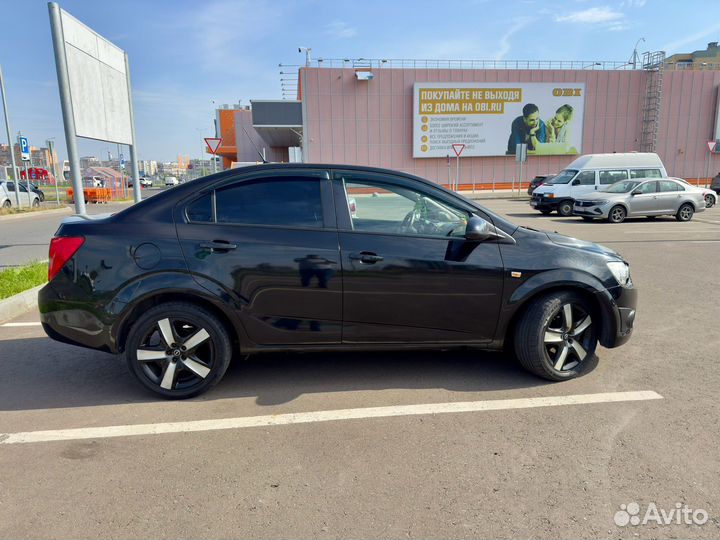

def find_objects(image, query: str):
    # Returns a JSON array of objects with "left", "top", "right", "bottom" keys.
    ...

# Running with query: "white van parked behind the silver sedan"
[{"left": 530, "top": 152, "right": 667, "bottom": 216}]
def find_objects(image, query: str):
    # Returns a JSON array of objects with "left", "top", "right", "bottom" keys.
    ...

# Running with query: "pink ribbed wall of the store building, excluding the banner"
[{"left": 294, "top": 67, "right": 720, "bottom": 184}]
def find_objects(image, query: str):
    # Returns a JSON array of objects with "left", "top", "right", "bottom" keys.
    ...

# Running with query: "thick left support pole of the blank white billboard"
[{"left": 48, "top": 2, "right": 87, "bottom": 215}]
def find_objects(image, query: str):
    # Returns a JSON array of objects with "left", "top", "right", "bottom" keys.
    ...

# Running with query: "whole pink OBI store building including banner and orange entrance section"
[{"left": 211, "top": 53, "right": 720, "bottom": 187}]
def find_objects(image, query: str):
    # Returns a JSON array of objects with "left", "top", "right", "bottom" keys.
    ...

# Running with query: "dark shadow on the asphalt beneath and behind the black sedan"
[{"left": 0, "top": 338, "right": 572, "bottom": 411}]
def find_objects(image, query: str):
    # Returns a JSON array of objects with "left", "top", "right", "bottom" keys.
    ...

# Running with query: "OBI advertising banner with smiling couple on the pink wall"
[{"left": 413, "top": 82, "right": 585, "bottom": 158}]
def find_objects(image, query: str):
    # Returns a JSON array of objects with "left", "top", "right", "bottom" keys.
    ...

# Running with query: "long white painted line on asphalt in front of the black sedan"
[{"left": 0, "top": 391, "right": 663, "bottom": 444}]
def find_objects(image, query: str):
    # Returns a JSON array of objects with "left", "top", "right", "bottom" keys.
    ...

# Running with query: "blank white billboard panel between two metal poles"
[{"left": 60, "top": 10, "right": 133, "bottom": 145}]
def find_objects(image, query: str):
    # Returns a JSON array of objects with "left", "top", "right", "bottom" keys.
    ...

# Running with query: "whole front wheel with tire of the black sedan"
[{"left": 514, "top": 291, "right": 600, "bottom": 381}]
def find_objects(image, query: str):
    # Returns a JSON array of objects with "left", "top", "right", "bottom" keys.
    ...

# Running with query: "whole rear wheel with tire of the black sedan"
[{"left": 125, "top": 302, "right": 233, "bottom": 399}]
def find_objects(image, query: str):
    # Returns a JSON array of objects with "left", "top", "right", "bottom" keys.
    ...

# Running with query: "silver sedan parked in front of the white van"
[{"left": 573, "top": 178, "right": 705, "bottom": 223}]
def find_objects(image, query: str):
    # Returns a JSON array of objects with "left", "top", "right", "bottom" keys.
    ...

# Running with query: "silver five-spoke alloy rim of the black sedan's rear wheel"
[{"left": 135, "top": 317, "right": 216, "bottom": 391}]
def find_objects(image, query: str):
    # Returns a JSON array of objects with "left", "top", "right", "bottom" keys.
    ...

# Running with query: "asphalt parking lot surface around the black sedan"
[{"left": 0, "top": 200, "right": 720, "bottom": 538}]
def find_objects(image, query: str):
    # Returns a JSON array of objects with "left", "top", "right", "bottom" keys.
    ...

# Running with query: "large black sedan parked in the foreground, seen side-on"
[{"left": 38, "top": 163, "right": 637, "bottom": 398}]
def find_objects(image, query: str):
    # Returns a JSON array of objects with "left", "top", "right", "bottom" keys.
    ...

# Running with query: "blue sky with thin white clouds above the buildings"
[{"left": 0, "top": 0, "right": 720, "bottom": 161}]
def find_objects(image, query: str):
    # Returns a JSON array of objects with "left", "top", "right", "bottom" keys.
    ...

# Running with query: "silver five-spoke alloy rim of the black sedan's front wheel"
[{"left": 543, "top": 304, "right": 594, "bottom": 371}]
